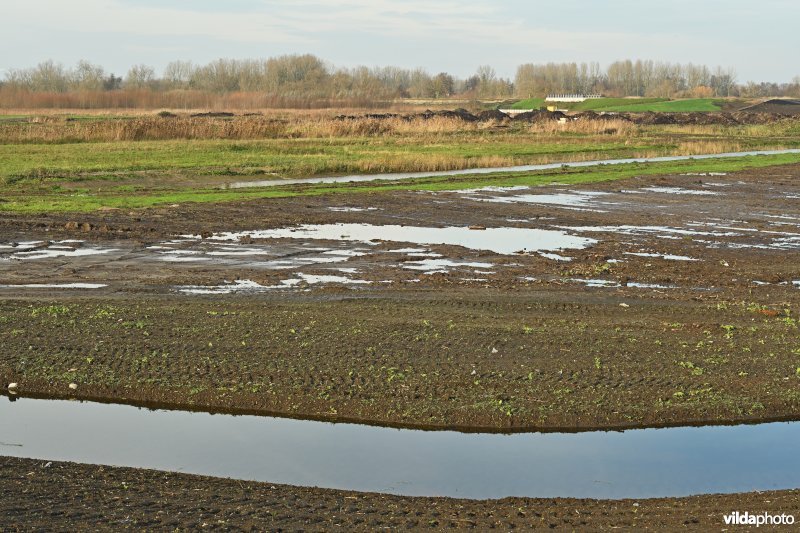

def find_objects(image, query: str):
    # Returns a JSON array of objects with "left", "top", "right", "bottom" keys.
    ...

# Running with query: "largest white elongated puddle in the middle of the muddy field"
[{"left": 194, "top": 220, "right": 597, "bottom": 255}]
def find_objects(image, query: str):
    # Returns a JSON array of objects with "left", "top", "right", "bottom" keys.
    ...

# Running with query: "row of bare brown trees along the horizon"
[{"left": 0, "top": 54, "right": 800, "bottom": 107}]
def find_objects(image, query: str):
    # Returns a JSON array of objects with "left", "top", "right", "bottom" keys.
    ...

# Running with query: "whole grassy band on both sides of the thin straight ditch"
[{"left": 0, "top": 117, "right": 800, "bottom": 213}]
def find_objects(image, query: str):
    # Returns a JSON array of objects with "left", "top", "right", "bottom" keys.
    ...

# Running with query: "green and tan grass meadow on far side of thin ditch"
[{"left": 0, "top": 135, "right": 658, "bottom": 184}]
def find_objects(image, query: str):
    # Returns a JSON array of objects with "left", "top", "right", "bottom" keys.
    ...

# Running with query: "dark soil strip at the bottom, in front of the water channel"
[{"left": 0, "top": 457, "right": 800, "bottom": 531}]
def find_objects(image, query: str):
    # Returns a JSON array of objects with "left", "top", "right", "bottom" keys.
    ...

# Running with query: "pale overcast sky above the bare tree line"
[{"left": 0, "top": 0, "right": 800, "bottom": 81}]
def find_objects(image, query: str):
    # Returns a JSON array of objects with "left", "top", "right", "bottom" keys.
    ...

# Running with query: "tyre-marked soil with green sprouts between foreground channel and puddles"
[{"left": 0, "top": 286, "right": 798, "bottom": 428}]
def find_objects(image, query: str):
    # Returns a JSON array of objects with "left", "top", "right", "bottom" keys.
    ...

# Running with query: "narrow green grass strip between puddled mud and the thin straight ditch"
[{"left": 0, "top": 154, "right": 800, "bottom": 213}]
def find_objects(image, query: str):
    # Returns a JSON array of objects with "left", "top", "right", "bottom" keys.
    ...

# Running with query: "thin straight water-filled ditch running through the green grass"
[{"left": 223, "top": 149, "right": 800, "bottom": 189}]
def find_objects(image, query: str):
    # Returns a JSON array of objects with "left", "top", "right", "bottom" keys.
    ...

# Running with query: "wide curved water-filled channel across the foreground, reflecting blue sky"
[{"left": 0, "top": 398, "right": 800, "bottom": 499}]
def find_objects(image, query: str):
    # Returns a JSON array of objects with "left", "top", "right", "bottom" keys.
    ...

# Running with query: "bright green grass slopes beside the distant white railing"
[{"left": 511, "top": 98, "right": 721, "bottom": 113}]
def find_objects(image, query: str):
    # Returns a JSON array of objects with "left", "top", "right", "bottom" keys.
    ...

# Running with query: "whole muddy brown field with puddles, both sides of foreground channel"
[{"left": 0, "top": 159, "right": 800, "bottom": 529}]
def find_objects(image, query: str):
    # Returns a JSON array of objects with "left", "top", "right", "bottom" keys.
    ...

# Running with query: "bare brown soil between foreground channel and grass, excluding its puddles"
[{"left": 0, "top": 166, "right": 800, "bottom": 429}]
